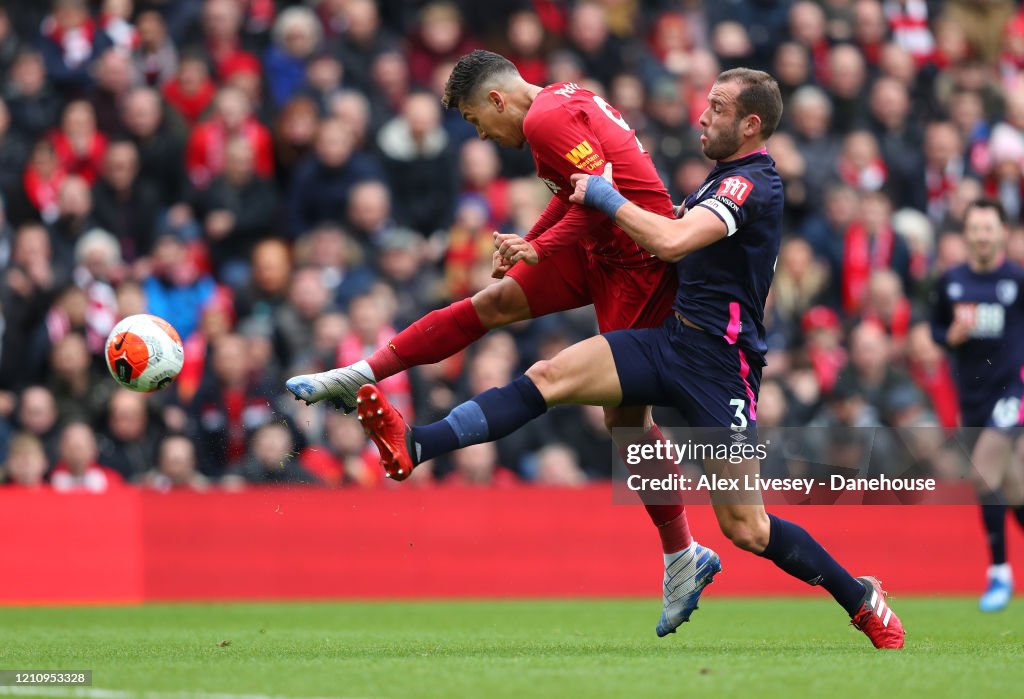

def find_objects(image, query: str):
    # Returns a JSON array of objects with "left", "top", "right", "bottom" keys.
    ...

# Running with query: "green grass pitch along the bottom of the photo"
[{"left": 0, "top": 597, "right": 1024, "bottom": 699}]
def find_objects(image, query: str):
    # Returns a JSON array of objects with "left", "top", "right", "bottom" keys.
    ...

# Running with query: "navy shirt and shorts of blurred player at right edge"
[{"left": 932, "top": 257, "right": 1024, "bottom": 417}]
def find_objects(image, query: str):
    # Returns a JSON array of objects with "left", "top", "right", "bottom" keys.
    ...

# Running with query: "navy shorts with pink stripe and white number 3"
[{"left": 604, "top": 315, "right": 763, "bottom": 441}]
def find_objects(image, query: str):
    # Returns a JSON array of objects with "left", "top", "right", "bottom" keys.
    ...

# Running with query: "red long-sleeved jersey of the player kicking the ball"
[{"left": 522, "top": 83, "right": 673, "bottom": 267}]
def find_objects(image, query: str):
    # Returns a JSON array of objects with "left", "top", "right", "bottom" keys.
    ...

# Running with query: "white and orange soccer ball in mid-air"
[{"left": 104, "top": 313, "right": 185, "bottom": 393}]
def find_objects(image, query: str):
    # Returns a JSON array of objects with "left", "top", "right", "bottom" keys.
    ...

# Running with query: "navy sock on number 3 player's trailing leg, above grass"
[{"left": 761, "top": 515, "right": 865, "bottom": 616}]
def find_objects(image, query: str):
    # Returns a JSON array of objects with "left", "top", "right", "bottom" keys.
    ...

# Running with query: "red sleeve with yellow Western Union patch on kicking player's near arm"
[{"left": 526, "top": 110, "right": 608, "bottom": 259}]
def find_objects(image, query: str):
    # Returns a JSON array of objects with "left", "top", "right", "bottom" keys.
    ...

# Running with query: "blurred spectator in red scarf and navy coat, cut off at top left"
[{"left": 39, "top": 0, "right": 113, "bottom": 94}]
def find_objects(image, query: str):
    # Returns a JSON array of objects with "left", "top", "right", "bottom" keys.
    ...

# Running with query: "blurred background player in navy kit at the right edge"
[{"left": 932, "top": 200, "right": 1024, "bottom": 612}]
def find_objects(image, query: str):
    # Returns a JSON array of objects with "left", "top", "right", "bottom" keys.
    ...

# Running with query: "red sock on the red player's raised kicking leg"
[{"left": 367, "top": 299, "right": 487, "bottom": 381}]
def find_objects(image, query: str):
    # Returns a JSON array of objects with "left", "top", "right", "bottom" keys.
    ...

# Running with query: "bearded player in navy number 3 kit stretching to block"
[{"left": 358, "top": 69, "right": 904, "bottom": 648}]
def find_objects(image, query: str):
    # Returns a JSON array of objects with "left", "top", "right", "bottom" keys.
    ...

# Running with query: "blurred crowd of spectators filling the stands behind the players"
[{"left": 0, "top": 0, "right": 1024, "bottom": 491}]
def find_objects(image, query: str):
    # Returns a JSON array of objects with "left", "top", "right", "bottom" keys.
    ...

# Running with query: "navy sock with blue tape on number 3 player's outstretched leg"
[{"left": 413, "top": 377, "right": 548, "bottom": 464}]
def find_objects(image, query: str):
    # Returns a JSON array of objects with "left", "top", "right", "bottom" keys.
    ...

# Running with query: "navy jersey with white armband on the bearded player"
[{"left": 674, "top": 150, "right": 783, "bottom": 363}]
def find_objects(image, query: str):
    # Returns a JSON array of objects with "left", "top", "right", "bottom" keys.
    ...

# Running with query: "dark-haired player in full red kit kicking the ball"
[{"left": 287, "top": 51, "right": 693, "bottom": 628}]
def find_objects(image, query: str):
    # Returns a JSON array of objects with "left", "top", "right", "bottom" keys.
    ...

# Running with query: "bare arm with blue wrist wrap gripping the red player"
[{"left": 569, "top": 165, "right": 736, "bottom": 262}]
